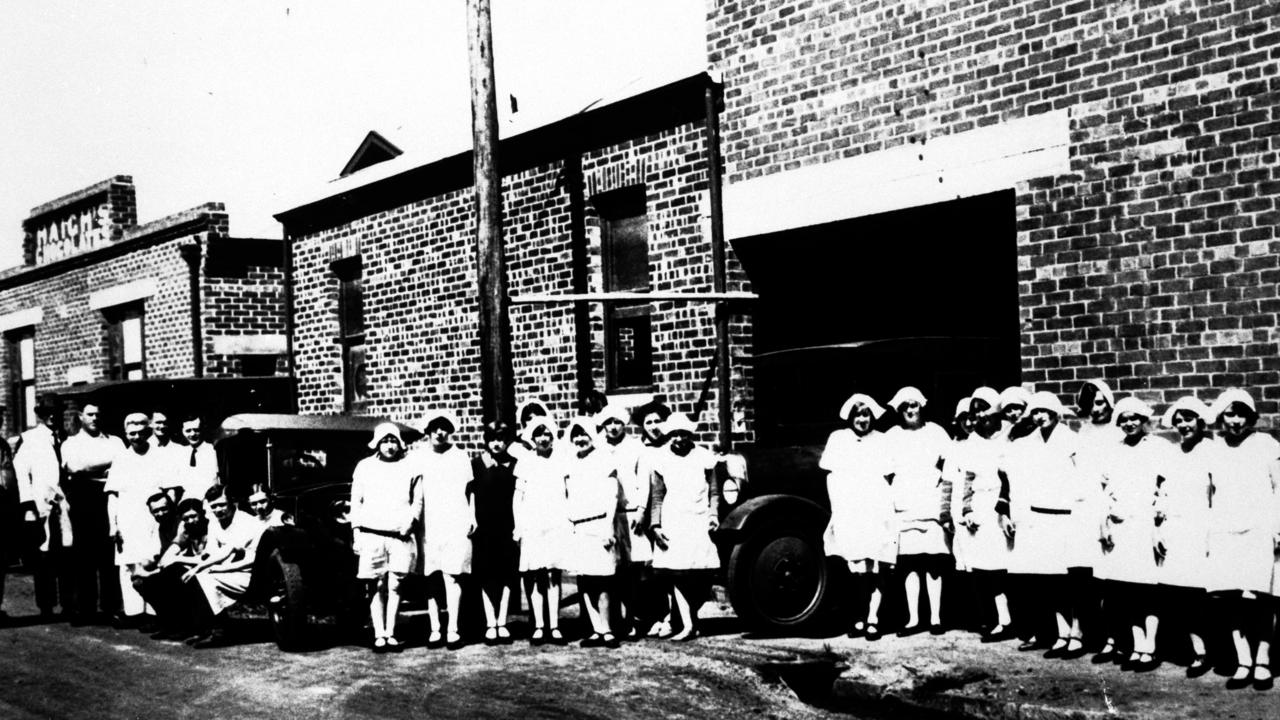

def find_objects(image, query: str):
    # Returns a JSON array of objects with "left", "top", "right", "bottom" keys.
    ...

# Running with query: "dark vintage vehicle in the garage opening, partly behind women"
[{"left": 714, "top": 337, "right": 1018, "bottom": 633}]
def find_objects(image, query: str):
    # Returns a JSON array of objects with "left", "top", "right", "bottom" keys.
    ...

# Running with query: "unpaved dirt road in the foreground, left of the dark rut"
[{"left": 0, "top": 577, "right": 847, "bottom": 720}]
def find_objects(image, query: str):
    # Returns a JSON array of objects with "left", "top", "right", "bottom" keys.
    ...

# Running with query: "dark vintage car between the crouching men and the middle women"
[{"left": 214, "top": 413, "right": 421, "bottom": 650}]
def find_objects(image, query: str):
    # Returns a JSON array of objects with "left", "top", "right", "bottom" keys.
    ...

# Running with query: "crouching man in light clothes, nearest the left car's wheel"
[{"left": 183, "top": 486, "right": 266, "bottom": 647}]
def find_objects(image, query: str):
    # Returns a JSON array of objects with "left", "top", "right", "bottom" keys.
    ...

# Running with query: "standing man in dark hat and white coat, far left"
[{"left": 13, "top": 397, "right": 74, "bottom": 619}]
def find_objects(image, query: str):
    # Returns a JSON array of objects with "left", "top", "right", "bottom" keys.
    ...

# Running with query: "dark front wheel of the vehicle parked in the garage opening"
[{"left": 728, "top": 524, "right": 828, "bottom": 633}]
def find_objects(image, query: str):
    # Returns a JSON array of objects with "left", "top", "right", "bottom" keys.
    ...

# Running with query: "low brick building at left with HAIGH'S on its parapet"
[{"left": 0, "top": 176, "right": 287, "bottom": 433}]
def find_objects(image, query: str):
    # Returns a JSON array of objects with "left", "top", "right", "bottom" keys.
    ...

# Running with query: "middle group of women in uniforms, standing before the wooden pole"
[{"left": 352, "top": 401, "right": 719, "bottom": 652}]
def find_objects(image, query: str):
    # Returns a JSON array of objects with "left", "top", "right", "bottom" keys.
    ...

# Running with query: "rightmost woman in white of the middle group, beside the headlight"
[{"left": 649, "top": 413, "right": 719, "bottom": 641}]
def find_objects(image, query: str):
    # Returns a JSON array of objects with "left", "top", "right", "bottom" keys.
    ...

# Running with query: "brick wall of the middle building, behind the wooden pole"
[{"left": 293, "top": 109, "right": 750, "bottom": 445}]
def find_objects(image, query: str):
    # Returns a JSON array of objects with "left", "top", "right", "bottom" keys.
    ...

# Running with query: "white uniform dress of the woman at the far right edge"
[{"left": 1204, "top": 432, "right": 1280, "bottom": 594}]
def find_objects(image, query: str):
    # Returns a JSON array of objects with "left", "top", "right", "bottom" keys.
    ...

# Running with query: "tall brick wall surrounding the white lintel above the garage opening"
[{"left": 708, "top": 0, "right": 1280, "bottom": 423}]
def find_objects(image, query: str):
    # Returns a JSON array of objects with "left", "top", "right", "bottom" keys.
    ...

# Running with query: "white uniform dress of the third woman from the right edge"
[{"left": 1094, "top": 436, "right": 1172, "bottom": 584}]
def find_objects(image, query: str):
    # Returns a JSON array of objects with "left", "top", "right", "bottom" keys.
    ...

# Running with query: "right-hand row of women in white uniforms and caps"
[{"left": 820, "top": 380, "right": 1280, "bottom": 688}]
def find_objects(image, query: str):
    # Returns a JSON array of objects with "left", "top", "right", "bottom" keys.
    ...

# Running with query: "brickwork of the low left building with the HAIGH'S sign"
[{"left": 0, "top": 176, "right": 285, "bottom": 432}]
